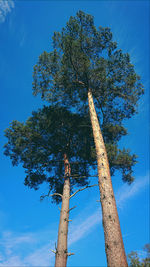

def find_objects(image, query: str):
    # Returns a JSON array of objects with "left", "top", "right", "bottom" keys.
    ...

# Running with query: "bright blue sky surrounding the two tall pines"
[{"left": 0, "top": 0, "right": 150, "bottom": 267}]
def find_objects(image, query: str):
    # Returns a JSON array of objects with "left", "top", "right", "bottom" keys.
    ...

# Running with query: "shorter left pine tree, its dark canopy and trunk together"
[{"left": 4, "top": 107, "right": 95, "bottom": 267}]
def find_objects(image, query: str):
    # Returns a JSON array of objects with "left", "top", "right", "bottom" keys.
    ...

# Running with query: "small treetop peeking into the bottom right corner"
[{"left": 128, "top": 244, "right": 150, "bottom": 267}]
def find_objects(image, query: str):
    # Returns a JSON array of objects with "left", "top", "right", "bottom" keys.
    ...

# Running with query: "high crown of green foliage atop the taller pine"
[{"left": 33, "top": 11, "right": 143, "bottom": 125}]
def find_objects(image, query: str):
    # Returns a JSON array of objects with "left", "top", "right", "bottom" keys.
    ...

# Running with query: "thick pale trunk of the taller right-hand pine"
[{"left": 88, "top": 90, "right": 128, "bottom": 267}]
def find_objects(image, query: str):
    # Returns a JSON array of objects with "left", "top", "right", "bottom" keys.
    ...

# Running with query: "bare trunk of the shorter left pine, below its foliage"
[{"left": 55, "top": 154, "right": 71, "bottom": 267}]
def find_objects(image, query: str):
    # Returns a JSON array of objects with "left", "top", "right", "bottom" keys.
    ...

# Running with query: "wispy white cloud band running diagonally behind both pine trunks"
[{"left": 0, "top": 175, "right": 149, "bottom": 267}]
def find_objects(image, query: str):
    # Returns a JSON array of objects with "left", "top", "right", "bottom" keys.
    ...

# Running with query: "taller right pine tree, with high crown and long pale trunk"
[{"left": 33, "top": 11, "right": 143, "bottom": 267}]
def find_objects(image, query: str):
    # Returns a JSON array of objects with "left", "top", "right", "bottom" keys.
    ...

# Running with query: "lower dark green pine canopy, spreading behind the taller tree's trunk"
[{"left": 4, "top": 106, "right": 136, "bottom": 203}]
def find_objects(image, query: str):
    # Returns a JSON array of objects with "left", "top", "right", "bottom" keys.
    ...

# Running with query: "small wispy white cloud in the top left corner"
[{"left": 0, "top": 0, "right": 15, "bottom": 23}]
